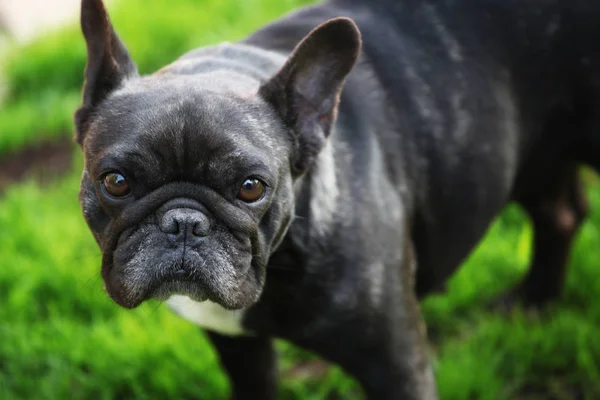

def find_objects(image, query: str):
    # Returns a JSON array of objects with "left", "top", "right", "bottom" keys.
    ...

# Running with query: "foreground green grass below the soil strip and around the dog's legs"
[{"left": 0, "top": 161, "right": 600, "bottom": 400}]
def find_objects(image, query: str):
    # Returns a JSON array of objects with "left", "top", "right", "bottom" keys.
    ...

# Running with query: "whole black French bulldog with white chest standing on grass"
[{"left": 75, "top": 0, "right": 600, "bottom": 399}]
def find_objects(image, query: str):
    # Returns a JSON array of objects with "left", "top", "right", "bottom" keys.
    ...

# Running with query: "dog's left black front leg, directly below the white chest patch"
[{"left": 207, "top": 332, "right": 277, "bottom": 400}]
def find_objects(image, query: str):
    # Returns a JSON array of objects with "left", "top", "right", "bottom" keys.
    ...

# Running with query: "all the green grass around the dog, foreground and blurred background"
[{"left": 0, "top": 0, "right": 600, "bottom": 400}]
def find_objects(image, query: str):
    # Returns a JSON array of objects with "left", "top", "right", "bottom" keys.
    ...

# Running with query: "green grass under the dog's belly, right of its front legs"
[{"left": 423, "top": 178, "right": 600, "bottom": 400}]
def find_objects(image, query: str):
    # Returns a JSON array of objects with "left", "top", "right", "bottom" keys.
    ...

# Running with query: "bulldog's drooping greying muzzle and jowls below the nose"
[{"left": 103, "top": 231, "right": 264, "bottom": 309}]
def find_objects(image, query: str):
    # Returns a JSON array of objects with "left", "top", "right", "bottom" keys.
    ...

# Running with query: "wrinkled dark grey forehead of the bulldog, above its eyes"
[{"left": 84, "top": 79, "right": 288, "bottom": 183}]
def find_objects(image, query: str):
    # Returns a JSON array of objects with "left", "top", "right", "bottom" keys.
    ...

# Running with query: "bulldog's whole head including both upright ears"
[{"left": 75, "top": 0, "right": 360, "bottom": 309}]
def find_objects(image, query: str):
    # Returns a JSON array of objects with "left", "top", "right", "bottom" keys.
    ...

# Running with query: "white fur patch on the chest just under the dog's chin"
[{"left": 166, "top": 295, "right": 251, "bottom": 336}]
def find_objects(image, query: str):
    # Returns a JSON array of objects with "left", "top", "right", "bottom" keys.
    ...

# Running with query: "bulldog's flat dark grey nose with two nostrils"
[{"left": 159, "top": 208, "right": 210, "bottom": 240}]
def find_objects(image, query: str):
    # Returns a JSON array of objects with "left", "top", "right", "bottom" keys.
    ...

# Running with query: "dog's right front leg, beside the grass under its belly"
[{"left": 300, "top": 242, "right": 438, "bottom": 400}]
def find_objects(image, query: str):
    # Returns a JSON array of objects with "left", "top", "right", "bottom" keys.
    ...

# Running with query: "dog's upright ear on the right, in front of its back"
[{"left": 259, "top": 18, "right": 361, "bottom": 174}]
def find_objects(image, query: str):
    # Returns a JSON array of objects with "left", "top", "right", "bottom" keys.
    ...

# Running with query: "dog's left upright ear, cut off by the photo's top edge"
[{"left": 75, "top": 0, "right": 138, "bottom": 144}]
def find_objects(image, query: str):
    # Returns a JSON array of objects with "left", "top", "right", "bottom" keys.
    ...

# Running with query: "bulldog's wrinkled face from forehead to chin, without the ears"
[{"left": 81, "top": 79, "right": 293, "bottom": 308}]
